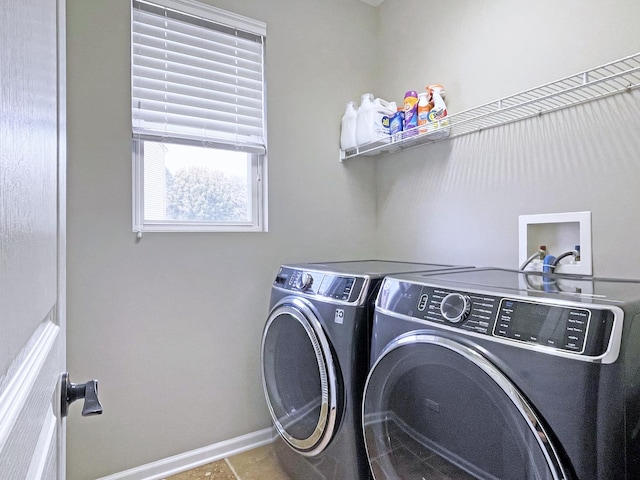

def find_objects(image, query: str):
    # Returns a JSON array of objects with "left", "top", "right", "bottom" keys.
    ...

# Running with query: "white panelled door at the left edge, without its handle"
[{"left": 0, "top": 0, "right": 66, "bottom": 480}]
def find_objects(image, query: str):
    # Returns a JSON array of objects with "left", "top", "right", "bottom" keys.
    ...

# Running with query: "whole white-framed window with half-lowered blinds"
[{"left": 131, "top": 0, "right": 267, "bottom": 232}]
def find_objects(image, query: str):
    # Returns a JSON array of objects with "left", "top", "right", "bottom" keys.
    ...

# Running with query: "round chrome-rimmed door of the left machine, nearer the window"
[{"left": 262, "top": 298, "right": 342, "bottom": 456}]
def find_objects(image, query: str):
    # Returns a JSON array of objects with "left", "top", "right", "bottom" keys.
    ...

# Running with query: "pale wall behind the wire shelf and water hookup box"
[{"left": 376, "top": 0, "right": 640, "bottom": 278}]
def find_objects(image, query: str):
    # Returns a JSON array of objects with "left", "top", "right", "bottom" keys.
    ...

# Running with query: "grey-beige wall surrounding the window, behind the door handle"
[{"left": 67, "top": 0, "right": 378, "bottom": 480}]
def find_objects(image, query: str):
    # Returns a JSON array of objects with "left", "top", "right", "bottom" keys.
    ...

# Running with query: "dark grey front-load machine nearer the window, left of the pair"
[{"left": 261, "top": 260, "right": 470, "bottom": 480}]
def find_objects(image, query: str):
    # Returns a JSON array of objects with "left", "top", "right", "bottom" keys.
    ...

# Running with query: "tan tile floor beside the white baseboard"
[{"left": 164, "top": 445, "right": 291, "bottom": 480}]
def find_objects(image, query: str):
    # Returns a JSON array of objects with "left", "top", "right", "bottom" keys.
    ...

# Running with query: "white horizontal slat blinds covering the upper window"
[{"left": 132, "top": 0, "right": 266, "bottom": 154}]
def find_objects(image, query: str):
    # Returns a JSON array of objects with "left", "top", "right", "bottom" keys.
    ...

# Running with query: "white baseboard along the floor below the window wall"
[{"left": 98, "top": 428, "right": 276, "bottom": 480}]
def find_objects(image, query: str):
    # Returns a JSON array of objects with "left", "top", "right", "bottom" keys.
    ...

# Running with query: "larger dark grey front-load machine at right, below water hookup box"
[{"left": 363, "top": 268, "right": 640, "bottom": 480}]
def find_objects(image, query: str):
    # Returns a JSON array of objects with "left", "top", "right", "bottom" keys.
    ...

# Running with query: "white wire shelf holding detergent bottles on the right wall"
[{"left": 340, "top": 52, "right": 640, "bottom": 161}]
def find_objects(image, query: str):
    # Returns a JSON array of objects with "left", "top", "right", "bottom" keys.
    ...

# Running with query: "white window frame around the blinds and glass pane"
[{"left": 131, "top": 0, "right": 268, "bottom": 233}]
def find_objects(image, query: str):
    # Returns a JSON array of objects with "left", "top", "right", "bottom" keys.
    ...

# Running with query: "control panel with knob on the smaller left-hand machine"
[{"left": 273, "top": 267, "right": 364, "bottom": 302}]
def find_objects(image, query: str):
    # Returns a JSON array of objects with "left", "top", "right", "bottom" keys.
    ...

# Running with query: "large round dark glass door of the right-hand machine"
[{"left": 363, "top": 332, "right": 568, "bottom": 480}]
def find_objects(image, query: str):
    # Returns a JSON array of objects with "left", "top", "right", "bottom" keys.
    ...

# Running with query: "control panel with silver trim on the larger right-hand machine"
[{"left": 377, "top": 279, "right": 614, "bottom": 356}]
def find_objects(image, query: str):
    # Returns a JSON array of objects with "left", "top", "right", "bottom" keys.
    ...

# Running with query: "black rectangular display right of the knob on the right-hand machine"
[{"left": 494, "top": 299, "right": 590, "bottom": 352}]
